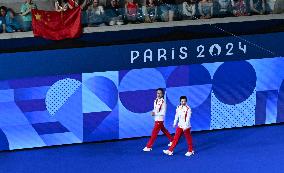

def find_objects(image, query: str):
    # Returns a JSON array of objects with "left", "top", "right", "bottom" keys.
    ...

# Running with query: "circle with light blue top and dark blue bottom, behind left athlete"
[{"left": 119, "top": 68, "right": 166, "bottom": 113}]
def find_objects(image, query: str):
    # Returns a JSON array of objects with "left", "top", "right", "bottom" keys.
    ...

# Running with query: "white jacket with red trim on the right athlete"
[{"left": 174, "top": 105, "right": 191, "bottom": 129}]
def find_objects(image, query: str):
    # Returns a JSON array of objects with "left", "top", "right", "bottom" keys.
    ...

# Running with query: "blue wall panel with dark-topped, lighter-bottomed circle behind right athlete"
[{"left": 166, "top": 64, "right": 212, "bottom": 132}]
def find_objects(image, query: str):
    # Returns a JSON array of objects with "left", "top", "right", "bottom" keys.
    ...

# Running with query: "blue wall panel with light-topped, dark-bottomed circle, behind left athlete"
[{"left": 119, "top": 68, "right": 166, "bottom": 138}]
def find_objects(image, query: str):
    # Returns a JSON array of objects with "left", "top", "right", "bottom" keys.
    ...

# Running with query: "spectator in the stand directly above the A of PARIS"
[{"left": 142, "top": 0, "right": 158, "bottom": 23}]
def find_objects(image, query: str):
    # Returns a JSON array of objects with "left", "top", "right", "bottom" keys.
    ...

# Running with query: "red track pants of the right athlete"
[{"left": 169, "top": 127, "right": 193, "bottom": 152}]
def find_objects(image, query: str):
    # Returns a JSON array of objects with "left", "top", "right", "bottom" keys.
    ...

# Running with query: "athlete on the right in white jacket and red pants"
[{"left": 163, "top": 96, "right": 194, "bottom": 156}]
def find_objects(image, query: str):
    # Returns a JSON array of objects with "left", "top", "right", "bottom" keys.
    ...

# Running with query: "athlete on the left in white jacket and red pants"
[{"left": 143, "top": 88, "right": 173, "bottom": 151}]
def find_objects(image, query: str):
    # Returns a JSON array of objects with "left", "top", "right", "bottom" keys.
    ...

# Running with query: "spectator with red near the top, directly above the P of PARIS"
[{"left": 125, "top": 0, "right": 139, "bottom": 23}]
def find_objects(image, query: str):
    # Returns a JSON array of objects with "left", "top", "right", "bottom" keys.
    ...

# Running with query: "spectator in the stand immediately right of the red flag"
[{"left": 87, "top": 0, "right": 105, "bottom": 26}]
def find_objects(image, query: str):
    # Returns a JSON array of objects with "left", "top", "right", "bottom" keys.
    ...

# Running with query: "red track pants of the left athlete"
[{"left": 146, "top": 121, "right": 173, "bottom": 148}]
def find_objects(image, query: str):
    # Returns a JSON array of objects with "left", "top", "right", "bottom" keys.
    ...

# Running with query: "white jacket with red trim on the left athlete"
[{"left": 153, "top": 98, "right": 167, "bottom": 121}]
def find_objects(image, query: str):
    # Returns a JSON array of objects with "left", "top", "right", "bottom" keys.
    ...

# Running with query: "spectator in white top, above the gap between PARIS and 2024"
[{"left": 182, "top": 0, "right": 197, "bottom": 20}]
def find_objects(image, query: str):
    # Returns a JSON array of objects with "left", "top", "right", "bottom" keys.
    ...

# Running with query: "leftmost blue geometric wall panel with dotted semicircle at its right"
[{"left": 0, "top": 75, "right": 83, "bottom": 150}]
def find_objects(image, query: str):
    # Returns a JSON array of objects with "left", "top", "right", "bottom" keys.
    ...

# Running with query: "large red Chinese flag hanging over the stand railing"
[{"left": 32, "top": 8, "right": 82, "bottom": 40}]
